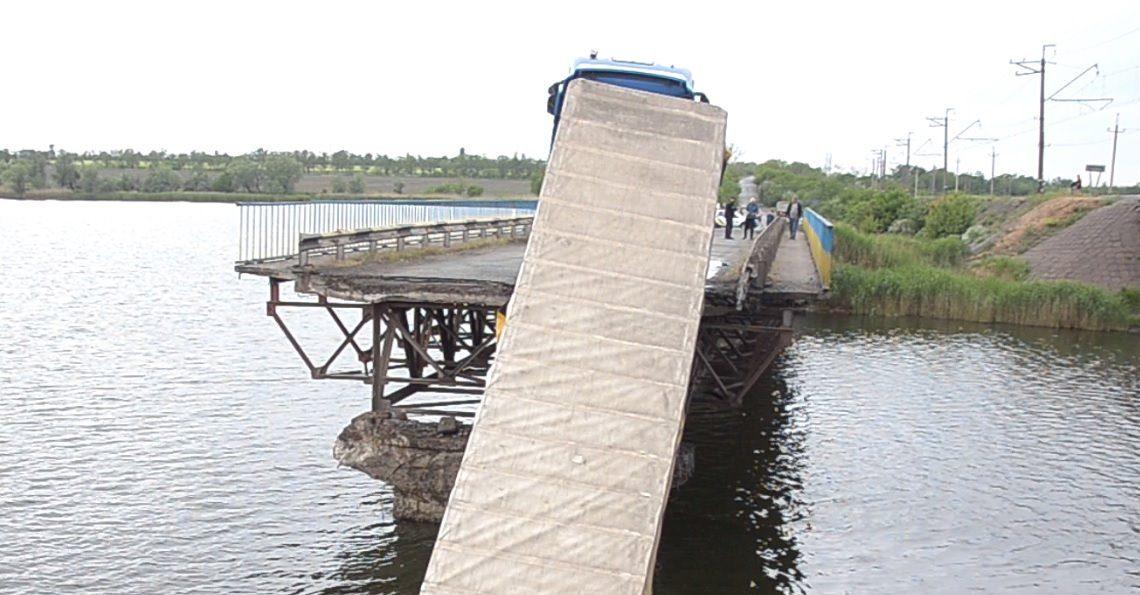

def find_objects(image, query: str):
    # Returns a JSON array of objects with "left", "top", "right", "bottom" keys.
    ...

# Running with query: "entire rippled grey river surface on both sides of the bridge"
[{"left": 0, "top": 201, "right": 1140, "bottom": 594}]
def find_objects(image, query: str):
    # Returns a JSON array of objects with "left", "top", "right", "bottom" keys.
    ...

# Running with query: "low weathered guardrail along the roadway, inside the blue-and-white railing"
[{"left": 298, "top": 215, "right": 535, "bottom": 266}]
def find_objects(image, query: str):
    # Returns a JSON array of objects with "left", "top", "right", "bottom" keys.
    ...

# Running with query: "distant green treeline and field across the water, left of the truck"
[{"left": 0, "top": 147, "right": 545, "bottom": 196}]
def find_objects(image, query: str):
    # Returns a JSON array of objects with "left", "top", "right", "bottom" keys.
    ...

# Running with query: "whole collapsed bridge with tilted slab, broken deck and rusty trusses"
[{"left": 236, "top": 81, "right": 830, "bottom": 593}]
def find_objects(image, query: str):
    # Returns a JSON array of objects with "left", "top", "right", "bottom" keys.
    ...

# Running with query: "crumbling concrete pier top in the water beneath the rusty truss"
[{"left": 333, "top": 410, "right": 695, "bottom": 523}]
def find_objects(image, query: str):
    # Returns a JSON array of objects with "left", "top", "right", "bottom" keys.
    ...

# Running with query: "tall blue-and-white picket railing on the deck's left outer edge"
[{"left": 237, "top": 201, "right": 532, "bottom": 263}]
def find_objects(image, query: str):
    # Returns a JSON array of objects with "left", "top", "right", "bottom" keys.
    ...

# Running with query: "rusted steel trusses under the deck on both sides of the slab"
[{"left": 266, "top": 279, "right": 792, "bottom": 413}]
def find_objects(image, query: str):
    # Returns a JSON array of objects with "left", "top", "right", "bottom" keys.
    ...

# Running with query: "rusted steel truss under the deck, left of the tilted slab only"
[{"left": 266, "top": 279, "right": 496, "bottom": 409}]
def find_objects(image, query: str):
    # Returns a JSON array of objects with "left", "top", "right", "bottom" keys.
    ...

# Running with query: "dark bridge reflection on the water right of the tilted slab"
[{"left": 654, "top": 377, "right": 808, "bottom": 594}]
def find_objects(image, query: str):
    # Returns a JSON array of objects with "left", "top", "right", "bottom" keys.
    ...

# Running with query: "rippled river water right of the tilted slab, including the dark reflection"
[{"left": 657, "top": 317, "right": 1140, "bottom": 593}]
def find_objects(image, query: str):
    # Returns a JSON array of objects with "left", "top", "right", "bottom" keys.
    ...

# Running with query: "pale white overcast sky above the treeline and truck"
[{"left": 0, "top": 0, "right": 1140, "bottom": 184}]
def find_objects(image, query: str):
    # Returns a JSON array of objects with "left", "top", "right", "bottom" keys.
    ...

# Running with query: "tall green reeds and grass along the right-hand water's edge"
[{"left": 831, "top": 225, "right": 1140, "bottom": 331}]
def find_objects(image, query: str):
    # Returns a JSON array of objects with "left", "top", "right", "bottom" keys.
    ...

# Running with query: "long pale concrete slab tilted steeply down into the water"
[{"left": 423, "top": 80, "right": 726, "bottom": 595}]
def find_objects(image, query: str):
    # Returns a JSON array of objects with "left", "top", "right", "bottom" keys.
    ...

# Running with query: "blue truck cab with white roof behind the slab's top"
[{"left": 546, "top": 54, "right": 708, "bottom": 144}]
